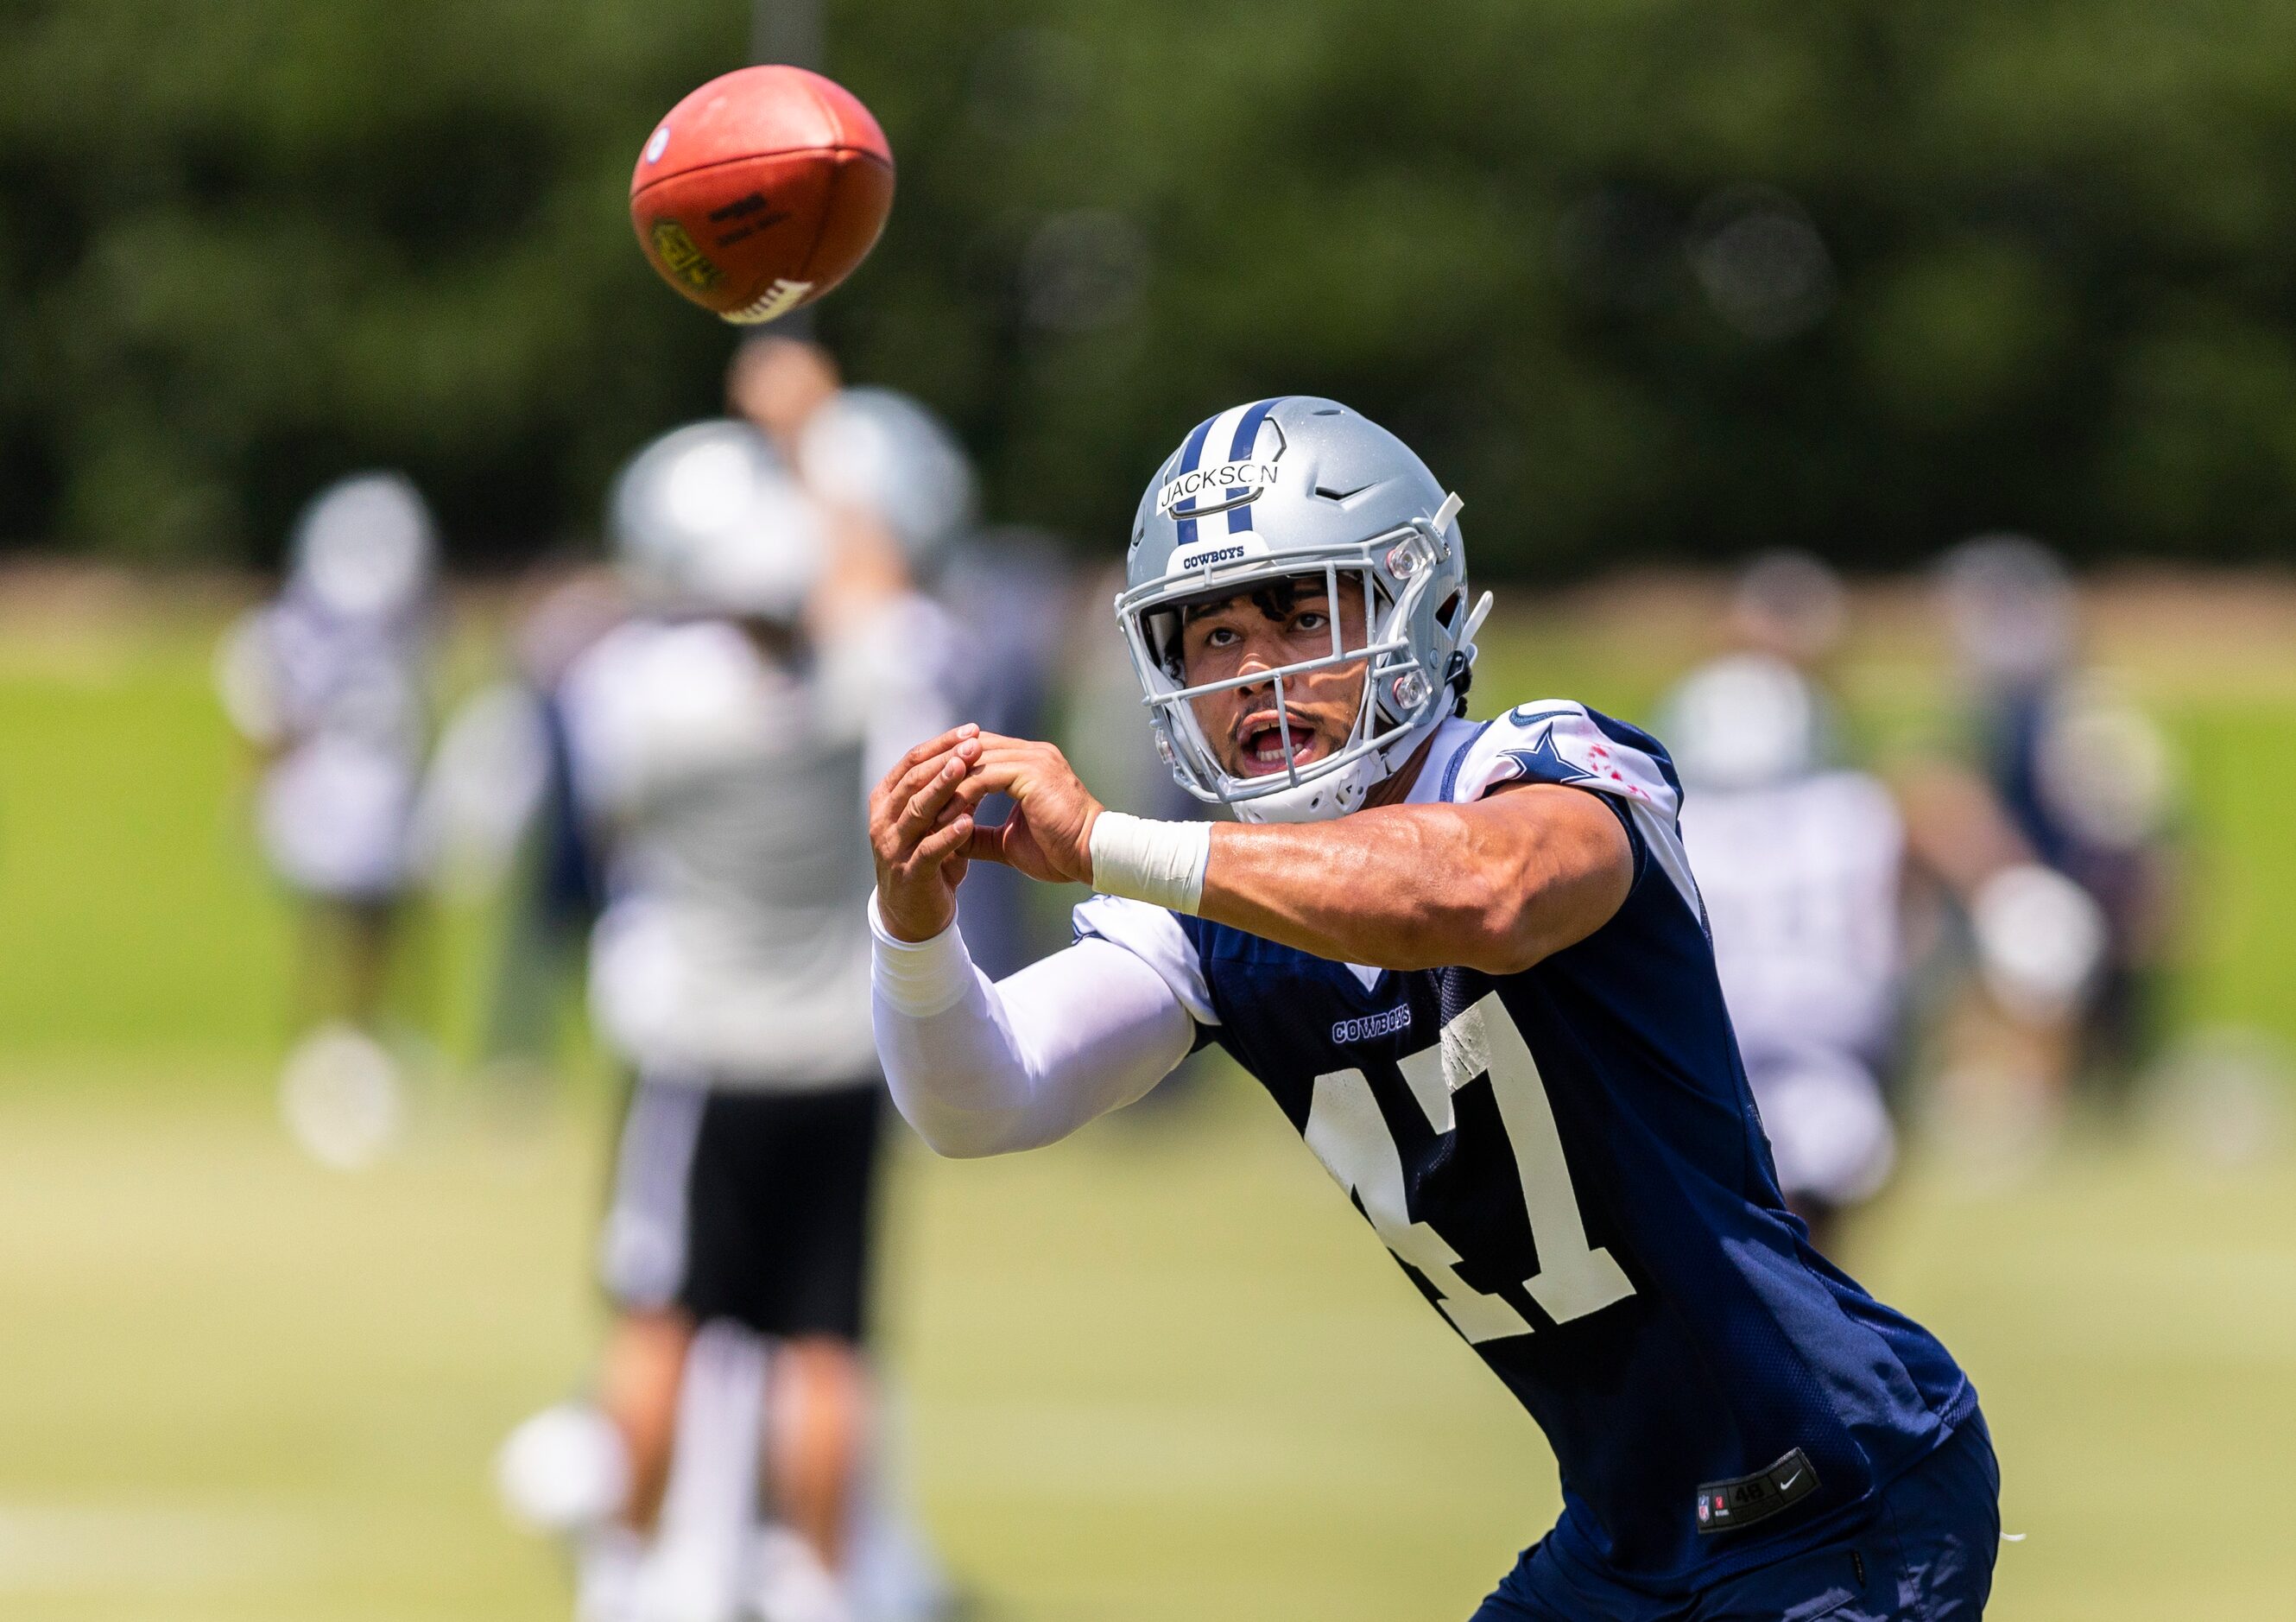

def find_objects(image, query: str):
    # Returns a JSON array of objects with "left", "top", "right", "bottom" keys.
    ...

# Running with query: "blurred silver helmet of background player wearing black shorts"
[{"left": 606, "top": 418, "right": 826, "bottom": 623}]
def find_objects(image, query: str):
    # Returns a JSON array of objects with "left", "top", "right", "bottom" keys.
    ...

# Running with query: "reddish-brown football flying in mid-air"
[{"left": 629, "top": 64, "right": 893, "bottom": 324}]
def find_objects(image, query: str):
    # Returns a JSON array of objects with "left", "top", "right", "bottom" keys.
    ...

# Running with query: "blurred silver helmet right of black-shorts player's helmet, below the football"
[{"left": 797, "top": 389, "right": 973, "bottom": 574}]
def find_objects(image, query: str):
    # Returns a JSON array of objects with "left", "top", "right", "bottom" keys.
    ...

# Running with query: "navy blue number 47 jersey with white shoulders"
[{"left": 1077, "top": 700, "right": 1975, "bottom": 1590}]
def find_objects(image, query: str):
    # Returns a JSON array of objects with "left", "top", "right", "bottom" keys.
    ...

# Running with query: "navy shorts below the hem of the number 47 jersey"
[{"left": 1474, "top": 1410, "right": 2002, "bottom": 1622}]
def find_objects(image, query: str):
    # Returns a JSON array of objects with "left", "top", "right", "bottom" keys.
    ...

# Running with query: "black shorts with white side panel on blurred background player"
[{"left": 599, "top": 1080, "right": 884, "bottom": 1341}]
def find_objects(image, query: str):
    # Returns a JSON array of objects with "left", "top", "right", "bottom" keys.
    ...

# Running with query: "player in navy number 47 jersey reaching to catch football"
[{"left": 870, "top": 397, "right": 2000, "bottom": 1622}]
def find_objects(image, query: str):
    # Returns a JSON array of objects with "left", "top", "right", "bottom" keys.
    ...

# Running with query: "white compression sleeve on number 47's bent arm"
[{"left": 870, "top": 898, "right": 1196, "bottom": 1156}]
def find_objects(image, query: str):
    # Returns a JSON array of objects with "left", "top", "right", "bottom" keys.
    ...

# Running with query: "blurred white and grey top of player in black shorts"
[{"left": 562, "top": 620, "right": 877, "bottom": 1089}]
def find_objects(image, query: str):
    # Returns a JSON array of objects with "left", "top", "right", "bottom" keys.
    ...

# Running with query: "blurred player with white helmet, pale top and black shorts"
[{"left": 505, "top": 421, "right": 939, "bottom": 1622}]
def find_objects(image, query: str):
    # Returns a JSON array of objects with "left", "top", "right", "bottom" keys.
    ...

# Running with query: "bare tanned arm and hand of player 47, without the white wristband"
[{"left": 946, "top": 733, "right": 1635, "bottom": 974}]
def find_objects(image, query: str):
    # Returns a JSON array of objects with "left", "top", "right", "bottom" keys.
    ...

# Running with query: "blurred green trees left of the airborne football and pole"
[{"left": 0, "top": 0, "right": 746, "bottom": 556}]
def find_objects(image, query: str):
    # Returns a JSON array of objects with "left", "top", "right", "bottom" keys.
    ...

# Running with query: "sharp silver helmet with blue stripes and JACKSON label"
[{"left": 1116, "top": 396, "right": 1490, "bottom": 822}]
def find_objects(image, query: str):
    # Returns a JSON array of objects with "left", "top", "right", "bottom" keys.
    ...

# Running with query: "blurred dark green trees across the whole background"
[{"left": 0, "top": 0, "right": 2296, "bottom": 572}]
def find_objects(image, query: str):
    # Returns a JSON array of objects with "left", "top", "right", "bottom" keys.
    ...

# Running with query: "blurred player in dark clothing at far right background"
[{"left": 1940, "top": 535, "right": 2177, "bottom": 1107}]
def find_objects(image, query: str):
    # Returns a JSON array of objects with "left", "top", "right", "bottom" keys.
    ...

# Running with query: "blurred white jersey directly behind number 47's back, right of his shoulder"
[{"left": 1683, "top": 772, "right": 1906, "bottom": 1064}]
